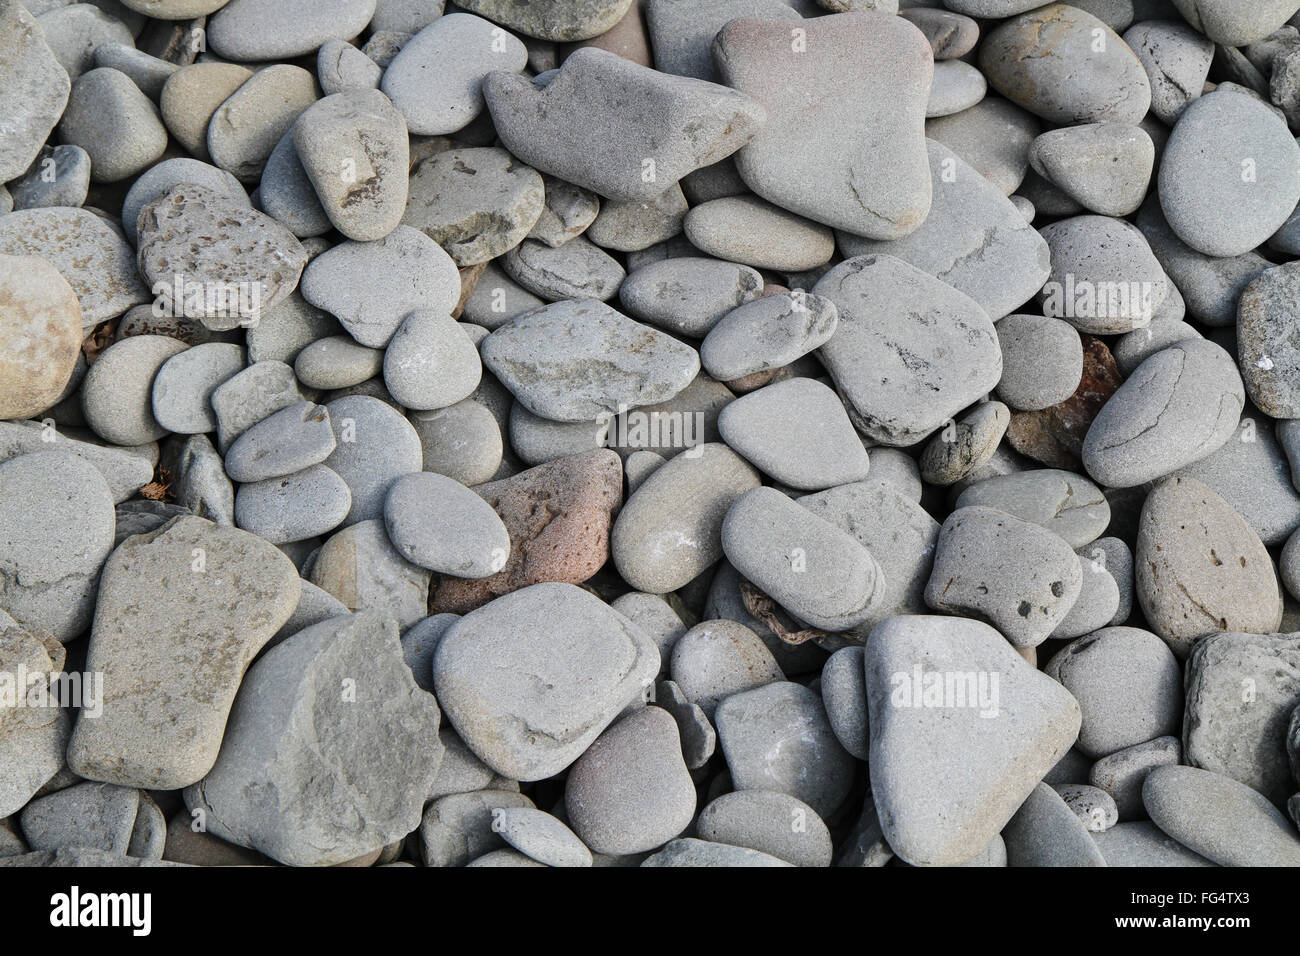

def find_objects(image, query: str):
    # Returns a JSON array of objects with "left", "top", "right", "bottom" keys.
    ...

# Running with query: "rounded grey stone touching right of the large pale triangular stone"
[{"left": 1044, "top": 627, "right": 1183, "bottom": 757}]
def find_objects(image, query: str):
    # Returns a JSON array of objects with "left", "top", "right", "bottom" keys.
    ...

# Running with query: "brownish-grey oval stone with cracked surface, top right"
[{"left": 979, "top": 4, "right": 1151, "bottom": 125}]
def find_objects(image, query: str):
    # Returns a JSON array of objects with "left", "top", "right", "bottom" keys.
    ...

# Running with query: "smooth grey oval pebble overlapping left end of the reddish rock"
[{"left": 384, "top": 472, "right": 510, "bottom": 578}]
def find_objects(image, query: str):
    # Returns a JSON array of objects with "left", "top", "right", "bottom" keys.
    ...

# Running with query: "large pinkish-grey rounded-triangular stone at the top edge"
[{"left": 714, "top": 13, "right": 933, "bottom": 239}]
